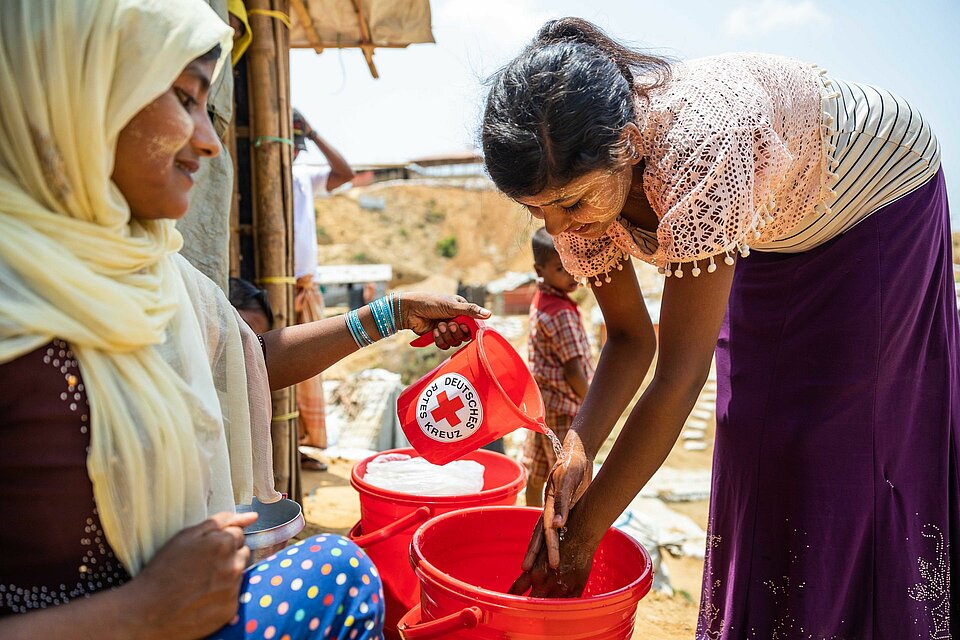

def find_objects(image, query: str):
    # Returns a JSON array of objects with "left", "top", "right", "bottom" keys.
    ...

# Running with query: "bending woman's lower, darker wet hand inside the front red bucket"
[{"left": 510, "top": 509, "right": 599, "bottom": 598}]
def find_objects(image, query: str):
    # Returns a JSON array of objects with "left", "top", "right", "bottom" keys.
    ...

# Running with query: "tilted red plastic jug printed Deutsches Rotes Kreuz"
[{"left": 397, "top": 316, "right": 546, "bottom": 464}]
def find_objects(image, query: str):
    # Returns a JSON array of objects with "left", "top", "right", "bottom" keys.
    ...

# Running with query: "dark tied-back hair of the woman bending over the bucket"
[{"left": 481, "top": 18, "right": 670, "bottom": 198}]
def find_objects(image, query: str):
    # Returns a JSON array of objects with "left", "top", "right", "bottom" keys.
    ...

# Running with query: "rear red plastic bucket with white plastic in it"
[{"left": 350, "top": 449, "right": 527, "bottom": 638}]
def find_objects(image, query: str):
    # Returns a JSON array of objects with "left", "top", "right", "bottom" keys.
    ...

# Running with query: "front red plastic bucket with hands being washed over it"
[{"left": 399, "top": 507, "right": 653, "bottom": 640}]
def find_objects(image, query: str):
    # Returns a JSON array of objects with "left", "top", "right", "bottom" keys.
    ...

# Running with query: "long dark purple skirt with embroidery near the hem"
[{"left": 697, "top": 171, "right": 960, "bottom": 640}]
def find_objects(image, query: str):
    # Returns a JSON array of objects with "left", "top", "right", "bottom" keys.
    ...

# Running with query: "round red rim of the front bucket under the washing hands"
[{"left": 410, "top": 506, "right": 653, "bottom": 610}]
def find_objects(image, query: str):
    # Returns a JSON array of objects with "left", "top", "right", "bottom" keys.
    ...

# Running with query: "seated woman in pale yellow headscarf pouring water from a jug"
[{"left": 0, "top": 0, "right": 486, "bottom": 638}]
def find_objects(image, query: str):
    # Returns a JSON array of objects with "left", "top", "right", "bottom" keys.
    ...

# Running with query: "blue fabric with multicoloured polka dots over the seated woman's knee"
[{"left": 209, "top": 535, "right": 384, "bottom": 640}]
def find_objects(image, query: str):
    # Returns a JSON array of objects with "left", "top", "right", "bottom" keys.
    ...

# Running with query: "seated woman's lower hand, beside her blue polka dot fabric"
[{"left": 129, "top": 512, "right": 257, "bottom": 638}]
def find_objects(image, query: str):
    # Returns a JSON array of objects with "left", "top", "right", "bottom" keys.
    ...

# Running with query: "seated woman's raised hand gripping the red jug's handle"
[{"left": 400, "top": 292, "right": 491, "bottom": 349}]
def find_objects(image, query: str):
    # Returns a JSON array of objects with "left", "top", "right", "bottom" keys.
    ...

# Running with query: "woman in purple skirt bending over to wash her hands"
[{"left": 492, "top": 18, "right": 960, "bottom": 640}]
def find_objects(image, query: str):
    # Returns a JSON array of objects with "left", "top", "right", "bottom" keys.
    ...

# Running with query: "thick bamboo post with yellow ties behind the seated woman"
[{"left": 246, "top": 0, "right": 301, "bottom": 500}]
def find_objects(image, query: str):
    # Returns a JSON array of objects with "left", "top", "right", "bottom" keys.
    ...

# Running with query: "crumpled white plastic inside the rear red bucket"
[{"left": 363, "top": 453, "right": 484, "bottom": 496}]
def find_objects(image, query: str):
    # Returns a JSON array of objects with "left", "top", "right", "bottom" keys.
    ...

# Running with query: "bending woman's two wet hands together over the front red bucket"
[{"left": 510, "top": 431, "right": 599, "bottom": 598}]
